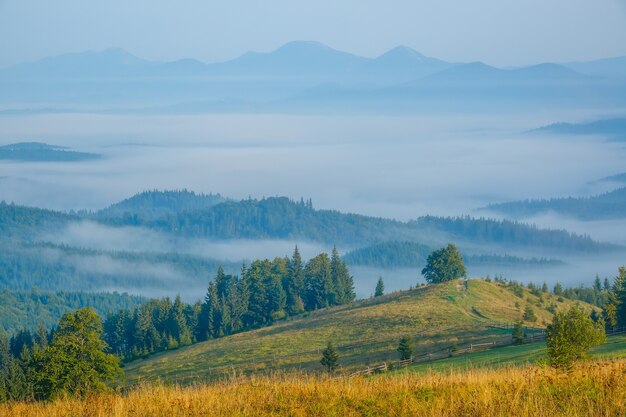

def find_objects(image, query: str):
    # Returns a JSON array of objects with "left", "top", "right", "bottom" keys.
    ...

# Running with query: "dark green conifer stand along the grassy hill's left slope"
[{"left": 104, "top": 247, "right": 355, "bottom": 360}]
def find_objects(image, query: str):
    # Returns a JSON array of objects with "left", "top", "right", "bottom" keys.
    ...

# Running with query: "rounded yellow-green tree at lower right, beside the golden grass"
[{"left": 546, "top": 305, "right": 606, "bottom": 369}]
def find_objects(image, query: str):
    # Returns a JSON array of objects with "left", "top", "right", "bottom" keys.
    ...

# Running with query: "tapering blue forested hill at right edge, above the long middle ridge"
[{"left": 485, "top": 187, "right": 626, "bottom": 220}]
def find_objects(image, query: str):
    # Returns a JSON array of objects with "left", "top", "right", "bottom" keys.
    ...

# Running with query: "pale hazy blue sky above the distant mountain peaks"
[{"left": 0, "top": 0, "right": 626, "bottom": 67}]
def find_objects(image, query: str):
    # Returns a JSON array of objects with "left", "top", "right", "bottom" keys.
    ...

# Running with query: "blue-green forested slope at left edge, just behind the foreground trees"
[{"left": 0, "top": 289, "right": 147, "bottom": 335}]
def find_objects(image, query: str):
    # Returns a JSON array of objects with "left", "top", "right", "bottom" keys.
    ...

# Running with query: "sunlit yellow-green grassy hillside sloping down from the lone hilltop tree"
[{"left": 125, "top": 280, "right": 590, "bottom": 384}]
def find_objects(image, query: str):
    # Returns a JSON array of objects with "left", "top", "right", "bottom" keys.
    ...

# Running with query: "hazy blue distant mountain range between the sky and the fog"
[{"left": 0, "top": 42, "right": 626, "bottom": 114}]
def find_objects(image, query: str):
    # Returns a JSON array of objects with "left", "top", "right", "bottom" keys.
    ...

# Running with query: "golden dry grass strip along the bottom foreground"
[{"left": 0, "top": 359, "right": 626, "bottom": 417}]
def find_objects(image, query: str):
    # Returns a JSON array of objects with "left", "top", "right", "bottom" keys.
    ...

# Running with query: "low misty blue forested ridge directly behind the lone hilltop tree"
[{"left": 343, "top": 241, "right": 563, "bottom": 268}]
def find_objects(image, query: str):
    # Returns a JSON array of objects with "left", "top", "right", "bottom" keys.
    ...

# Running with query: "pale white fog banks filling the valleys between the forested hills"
[{"left": 0, "top": 111, "right": 626, "bottom": 296}]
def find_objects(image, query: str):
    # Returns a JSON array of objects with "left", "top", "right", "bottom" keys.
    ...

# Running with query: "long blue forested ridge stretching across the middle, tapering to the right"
[{"left": 108, "top": 197, "right": 615, "bottom": 251}]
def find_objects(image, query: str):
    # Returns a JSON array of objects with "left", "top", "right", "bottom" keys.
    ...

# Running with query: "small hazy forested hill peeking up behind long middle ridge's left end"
[{"left": 90, "top": 190, "right": 226, "bottom": 222}]
